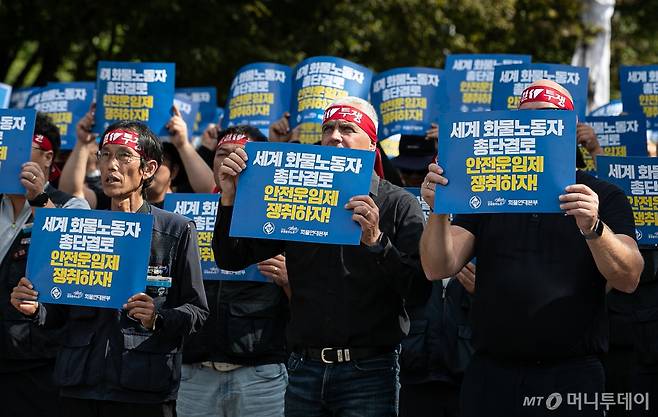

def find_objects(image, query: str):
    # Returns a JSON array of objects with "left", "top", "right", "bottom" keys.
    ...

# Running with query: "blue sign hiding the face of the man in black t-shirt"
[{"left": 434, "top": 110, "right": 576, "bottom": 214}]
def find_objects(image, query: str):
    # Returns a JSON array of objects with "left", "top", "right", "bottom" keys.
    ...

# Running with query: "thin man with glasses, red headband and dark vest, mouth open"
[{"left": 11, "top": 122, "right": 208, "bottom": 417}]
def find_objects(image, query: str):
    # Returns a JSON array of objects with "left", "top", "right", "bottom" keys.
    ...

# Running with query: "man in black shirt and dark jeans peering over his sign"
[{"left": 213, "top": 97, "right": 429, "bottom": 417}]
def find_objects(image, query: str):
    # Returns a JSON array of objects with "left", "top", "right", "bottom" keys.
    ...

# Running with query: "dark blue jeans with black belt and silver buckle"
[{"left": 286, "top": 352, "right": 399, "bottom": 417}]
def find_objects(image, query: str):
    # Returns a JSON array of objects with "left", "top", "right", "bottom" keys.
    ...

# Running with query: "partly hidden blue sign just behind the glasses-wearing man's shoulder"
[{"left": 164, "top": 193, "right": 270, "bottom": 282}]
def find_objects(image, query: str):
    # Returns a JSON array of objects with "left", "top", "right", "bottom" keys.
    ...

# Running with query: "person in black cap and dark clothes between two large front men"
[{"left": 391, "top": 124, "right": 475, "bottom": 417}]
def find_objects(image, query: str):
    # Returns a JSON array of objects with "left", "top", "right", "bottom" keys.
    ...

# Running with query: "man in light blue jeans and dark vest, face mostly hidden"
[{"left": 177, "top": 126, "right": 290, "bottom": 417}]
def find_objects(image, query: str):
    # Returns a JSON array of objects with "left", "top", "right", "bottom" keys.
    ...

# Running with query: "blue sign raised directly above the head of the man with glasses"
[{"left": 95, "top": 61, "right": 176, "bottom": 136}]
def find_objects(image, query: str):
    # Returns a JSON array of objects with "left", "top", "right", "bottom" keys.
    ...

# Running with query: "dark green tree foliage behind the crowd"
[{"left": 0, "top": 0, "right": 658, "bottom": 102}]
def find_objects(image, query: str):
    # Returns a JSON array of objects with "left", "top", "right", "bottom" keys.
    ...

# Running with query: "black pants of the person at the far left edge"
[{"left": 0, "top": 362, "right": 63, "bottom": 417}]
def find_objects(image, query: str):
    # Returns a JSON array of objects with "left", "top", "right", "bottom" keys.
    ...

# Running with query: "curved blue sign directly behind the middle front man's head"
[{"left": 290, "top": 56, "right": 372, "bottom": 143}]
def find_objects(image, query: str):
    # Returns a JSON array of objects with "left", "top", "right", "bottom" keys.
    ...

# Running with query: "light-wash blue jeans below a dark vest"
[{"left": 176, "top": 363, "right": 288, "bottom": 417}]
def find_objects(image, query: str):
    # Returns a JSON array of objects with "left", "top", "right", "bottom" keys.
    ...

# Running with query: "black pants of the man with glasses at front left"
[{"left": 60, "top": 397, "right": 176, "bottom": 417}]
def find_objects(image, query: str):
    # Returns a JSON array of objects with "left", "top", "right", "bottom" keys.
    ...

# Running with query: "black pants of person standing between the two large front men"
[{"left": 400, "top": 382, "right": 459, "bottom": 417}]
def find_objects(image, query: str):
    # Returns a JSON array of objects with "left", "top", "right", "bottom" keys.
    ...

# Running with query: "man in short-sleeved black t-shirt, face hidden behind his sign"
[{"left": 420, "top": 80, "right": 643, "bottom": 416}]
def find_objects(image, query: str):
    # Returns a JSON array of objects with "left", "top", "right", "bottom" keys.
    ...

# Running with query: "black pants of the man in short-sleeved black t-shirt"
[{"left": 460, "top": 355, "right": 605, "bottom": 417}]
